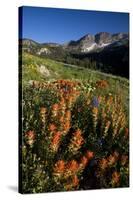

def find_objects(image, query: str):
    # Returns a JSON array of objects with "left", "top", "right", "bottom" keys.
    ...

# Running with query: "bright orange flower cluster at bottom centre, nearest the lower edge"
[{"left": 53, "top": 151, "right": 94, "bottom": 190}]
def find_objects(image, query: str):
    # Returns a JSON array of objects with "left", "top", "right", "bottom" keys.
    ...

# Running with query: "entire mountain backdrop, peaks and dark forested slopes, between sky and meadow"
[{"left": 19, "top": 32, "right": 129, "bottom": 78}]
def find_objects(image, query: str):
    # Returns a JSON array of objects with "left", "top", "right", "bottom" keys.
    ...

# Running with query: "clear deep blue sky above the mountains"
[{"left": 19, "top": 7, "right": 129, "bottom": 43}]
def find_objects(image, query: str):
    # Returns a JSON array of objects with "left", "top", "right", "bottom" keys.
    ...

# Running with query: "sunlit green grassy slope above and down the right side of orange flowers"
[{"left": 22, "top": 53, "right": 129, "bottom": 111}]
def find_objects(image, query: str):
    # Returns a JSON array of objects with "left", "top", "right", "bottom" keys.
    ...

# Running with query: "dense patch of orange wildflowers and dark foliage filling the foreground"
[{"left": 21, "top": 80, "right": 129, "bottom": 193}]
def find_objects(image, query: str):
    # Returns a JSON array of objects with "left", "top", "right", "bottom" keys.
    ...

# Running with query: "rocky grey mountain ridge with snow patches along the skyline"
[{"left": 20, "top": 32, "right": 129, "bottom": 52}]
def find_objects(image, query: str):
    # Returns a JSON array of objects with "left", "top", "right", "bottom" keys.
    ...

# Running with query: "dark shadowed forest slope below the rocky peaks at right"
[{"left": 72, "top": 41, "right": 129, "bottom": 78}]
